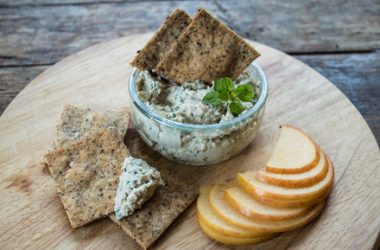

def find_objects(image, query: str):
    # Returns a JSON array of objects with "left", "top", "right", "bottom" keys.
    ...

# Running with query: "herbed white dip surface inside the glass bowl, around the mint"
[{"left": 136, "top": 71, "right": 258, "bottom": 124}]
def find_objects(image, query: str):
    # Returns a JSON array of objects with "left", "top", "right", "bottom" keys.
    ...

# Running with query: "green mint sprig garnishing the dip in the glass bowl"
[{"left": 202, "top": 77, "right": 255, "bottom": 117}]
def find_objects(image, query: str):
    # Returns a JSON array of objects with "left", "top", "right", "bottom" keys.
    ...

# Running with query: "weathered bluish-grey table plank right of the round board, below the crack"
[{"left": 295, "top": 50, "right": 380, "bottom": 143}]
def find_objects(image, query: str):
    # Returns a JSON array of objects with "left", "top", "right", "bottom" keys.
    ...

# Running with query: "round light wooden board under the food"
[{"left": 0, "top": 34, "right": 380, "bottom": 249}]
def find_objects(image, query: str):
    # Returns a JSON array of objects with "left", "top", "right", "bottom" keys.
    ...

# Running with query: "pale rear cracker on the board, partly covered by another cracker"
[{"left": 54, "top": 104, "right": 129, "bottom": 147}]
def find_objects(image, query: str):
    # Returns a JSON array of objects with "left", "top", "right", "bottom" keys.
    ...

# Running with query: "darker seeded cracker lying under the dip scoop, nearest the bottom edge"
[{"left": 110, "top": 166, "right": 197, "bottom": 249}]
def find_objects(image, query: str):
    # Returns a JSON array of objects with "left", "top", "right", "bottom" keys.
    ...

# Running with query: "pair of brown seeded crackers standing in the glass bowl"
[{"left": 131, "top": 9, "right": 260, "bottom": 83}]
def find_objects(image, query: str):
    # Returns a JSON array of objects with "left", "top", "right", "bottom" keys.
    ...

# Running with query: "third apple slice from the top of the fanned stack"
[{"left": 237, "top": 158, "right": 334, "bottom": 202}]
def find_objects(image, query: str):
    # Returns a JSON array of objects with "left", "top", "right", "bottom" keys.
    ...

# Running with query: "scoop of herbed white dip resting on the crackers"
[{"left": 114, "top": 157, "right": 164, "bottom": 219}]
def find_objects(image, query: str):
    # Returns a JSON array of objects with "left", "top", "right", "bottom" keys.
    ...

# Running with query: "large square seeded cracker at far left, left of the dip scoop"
[{"left": 45, "top": 129, "right": 129, "bottom": 228}]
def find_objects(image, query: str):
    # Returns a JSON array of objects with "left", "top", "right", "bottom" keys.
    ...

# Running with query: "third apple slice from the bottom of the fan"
[{"left": 210, "top": 185, "right": 324, "bottom": 233}]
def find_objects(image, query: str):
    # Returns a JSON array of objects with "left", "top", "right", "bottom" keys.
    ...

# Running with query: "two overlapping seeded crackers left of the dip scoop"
[{"left": 45, "top": 105, "right": 129, "bottom": 228}]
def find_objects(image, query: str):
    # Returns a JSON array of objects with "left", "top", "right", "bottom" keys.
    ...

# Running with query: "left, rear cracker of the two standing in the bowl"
[{"left": 131, "top": 9, "right": 191, "bottom": 70}]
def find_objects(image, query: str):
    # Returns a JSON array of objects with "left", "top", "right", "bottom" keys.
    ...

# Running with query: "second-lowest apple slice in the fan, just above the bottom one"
[{"left": 197, "top": 186, "right": 263, "bottom": 238}]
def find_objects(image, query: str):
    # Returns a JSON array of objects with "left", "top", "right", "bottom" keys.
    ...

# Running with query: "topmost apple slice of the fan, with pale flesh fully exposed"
[{"left": 265, "top": 125, "right": 319, "bottom": 174}]
